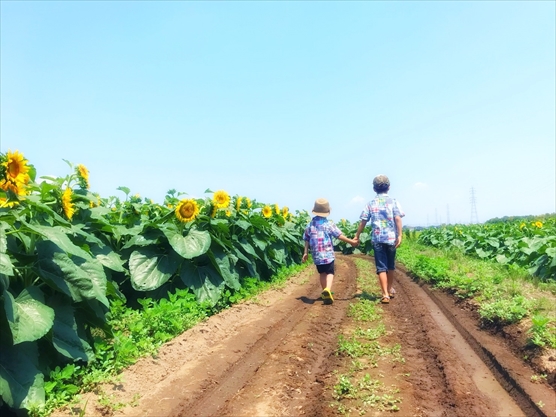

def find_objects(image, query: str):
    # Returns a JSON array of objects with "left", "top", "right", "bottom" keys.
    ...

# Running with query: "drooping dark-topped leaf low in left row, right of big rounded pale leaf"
[{"left": 180, "top": 261, "right": 224, "bottom": 306}]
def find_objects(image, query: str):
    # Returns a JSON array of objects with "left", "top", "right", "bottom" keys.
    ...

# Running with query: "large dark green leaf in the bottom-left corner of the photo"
[{"left": 0, "top": 342, "right": 45, "bottom": 409}]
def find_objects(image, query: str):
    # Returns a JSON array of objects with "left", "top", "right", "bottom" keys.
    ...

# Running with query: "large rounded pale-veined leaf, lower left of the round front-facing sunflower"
[{"left": 129, "top": 248, "right": 179, "bottom": 291}]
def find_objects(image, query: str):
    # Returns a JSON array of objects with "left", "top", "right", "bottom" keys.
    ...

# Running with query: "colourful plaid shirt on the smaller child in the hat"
[{"left": 303, "top": 216, "right": 342, "bottom": 265}]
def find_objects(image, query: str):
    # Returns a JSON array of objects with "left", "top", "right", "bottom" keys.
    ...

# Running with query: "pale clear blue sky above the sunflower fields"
[{"left": 0, "top": 1, "right": 556, "bottom": 226}]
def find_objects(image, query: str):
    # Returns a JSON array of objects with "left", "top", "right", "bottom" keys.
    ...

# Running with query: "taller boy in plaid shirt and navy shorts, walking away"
[{"left": 354, "top": 175, "right": 405, "bottom": 304}]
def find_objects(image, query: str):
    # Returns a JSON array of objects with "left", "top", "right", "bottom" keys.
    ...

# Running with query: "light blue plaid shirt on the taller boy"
[{"left": 359, "top": 193, "right": 405, "bottom": 245}]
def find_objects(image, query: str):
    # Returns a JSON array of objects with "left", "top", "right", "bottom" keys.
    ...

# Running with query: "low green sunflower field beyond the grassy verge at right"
[{"left": 418, "top": 215, "right": 556, "bottom": 280}]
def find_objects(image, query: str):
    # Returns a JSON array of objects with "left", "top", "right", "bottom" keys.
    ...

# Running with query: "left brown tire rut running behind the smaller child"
[{"left": 176, "top": 260, "right": 355, "bottom": 416}]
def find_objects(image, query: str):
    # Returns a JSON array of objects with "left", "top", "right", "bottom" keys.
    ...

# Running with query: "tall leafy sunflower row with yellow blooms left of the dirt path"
[{"left": 0, "top": 151, "right": 309, "bottom": 409}]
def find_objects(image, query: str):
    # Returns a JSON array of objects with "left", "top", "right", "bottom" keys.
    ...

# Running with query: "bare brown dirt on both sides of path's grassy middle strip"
[{"left": 54, "top": 255, "right": 556, "bottom": 417}]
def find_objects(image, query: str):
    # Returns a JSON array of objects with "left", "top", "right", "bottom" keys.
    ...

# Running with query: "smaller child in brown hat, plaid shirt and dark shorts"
[{"left": 303, "top": 198, "right": 358, "bottom": 304}]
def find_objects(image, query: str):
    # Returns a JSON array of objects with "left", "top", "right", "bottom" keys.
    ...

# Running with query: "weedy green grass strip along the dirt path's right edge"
[{"left": 397, "top": 239, "right": 556, "bottom": 349}]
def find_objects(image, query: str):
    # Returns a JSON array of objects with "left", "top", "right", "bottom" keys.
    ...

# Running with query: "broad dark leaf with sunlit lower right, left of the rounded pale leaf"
[{"left": 37, "top": 241, "right": 109, "bottom": 306}]
